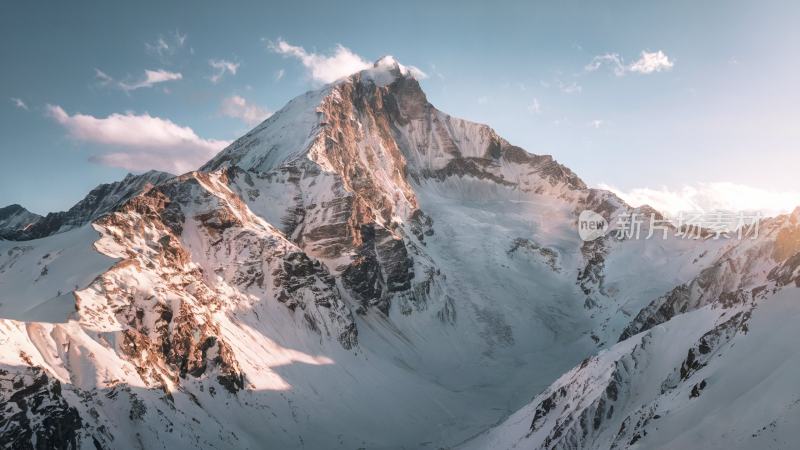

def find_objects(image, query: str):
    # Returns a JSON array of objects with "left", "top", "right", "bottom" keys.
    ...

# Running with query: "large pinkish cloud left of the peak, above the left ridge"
[{"left": 47, "top": 105, "right": 229, "bottom": 174}]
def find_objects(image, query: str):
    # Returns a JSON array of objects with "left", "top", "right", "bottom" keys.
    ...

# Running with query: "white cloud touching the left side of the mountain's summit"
[{"left": 269, "top": 39, "right": 370, "bottom": 83}]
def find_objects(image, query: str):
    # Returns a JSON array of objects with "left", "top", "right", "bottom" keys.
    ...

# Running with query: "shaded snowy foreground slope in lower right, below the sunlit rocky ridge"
[{"left": 463, "top": 286, "right": 800, "bottom": 449}]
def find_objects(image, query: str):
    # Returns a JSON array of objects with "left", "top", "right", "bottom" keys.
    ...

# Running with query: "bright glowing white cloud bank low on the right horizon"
[{"left": 599, "top": 183, "right": 800, "bottom": 216}]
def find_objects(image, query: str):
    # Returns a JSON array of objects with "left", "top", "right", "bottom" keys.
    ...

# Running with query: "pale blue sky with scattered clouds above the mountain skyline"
[{"left": 0, "top": 1, "right": 800, "bottom": 213}]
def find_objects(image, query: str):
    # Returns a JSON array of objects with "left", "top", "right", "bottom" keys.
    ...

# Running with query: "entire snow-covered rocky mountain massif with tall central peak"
[{"left": 0, "top": 57, "right": 800, "bottom": 448}]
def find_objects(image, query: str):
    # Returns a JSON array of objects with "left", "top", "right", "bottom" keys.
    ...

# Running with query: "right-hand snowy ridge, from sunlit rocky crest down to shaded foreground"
[{"left": 462, "top": 209, "right": 800, "bottom": 449}]
